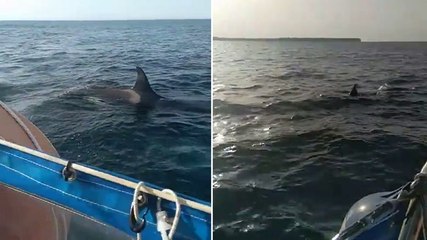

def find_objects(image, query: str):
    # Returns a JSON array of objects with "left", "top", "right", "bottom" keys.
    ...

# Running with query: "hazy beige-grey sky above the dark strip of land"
[{"left": 216, "top": 0, "right": 427, "bottom": 41}]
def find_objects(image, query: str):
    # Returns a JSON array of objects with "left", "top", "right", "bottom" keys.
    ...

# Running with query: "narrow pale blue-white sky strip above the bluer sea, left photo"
[{"left": 0, "top": 0, "right": 211, "bottom": 20}]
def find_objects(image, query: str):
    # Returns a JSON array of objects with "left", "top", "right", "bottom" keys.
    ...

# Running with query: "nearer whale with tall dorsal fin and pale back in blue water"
[{"left": 88, "top": 67, "right": 163, "bottom": 106}]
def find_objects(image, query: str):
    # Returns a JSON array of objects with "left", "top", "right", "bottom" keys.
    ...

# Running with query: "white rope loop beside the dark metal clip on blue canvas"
[{"left": 156, "top": 189, "right": 181, "bottom": 240}]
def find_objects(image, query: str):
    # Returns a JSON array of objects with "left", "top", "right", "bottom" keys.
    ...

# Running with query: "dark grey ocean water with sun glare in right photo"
[{"left": 213, "top": 41, "right": 427, "bottom": 240}]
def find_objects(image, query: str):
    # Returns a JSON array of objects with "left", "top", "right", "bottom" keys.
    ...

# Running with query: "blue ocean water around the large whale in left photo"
[{"left": 0, "top": 20, "right": 211, "bottom": 201}]
